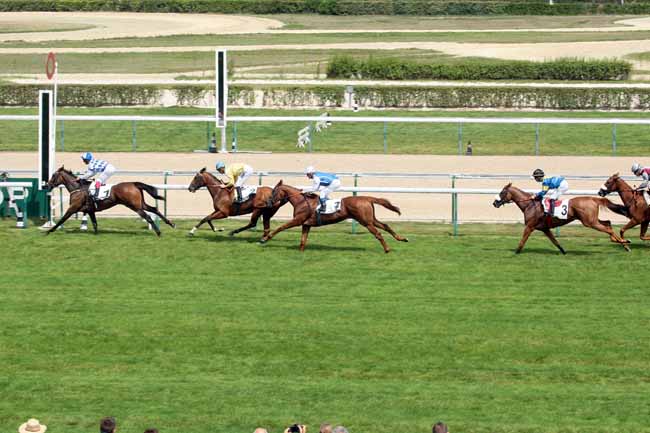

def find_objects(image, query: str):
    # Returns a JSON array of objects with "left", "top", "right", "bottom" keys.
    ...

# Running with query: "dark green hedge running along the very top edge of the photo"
[{"left": 6, "top": 0, "right": 650, "bottom": 15}]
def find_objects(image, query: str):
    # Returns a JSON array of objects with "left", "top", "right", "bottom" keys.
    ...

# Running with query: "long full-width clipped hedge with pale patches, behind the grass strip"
[{"left": 0, "top": 85, "right": 650, "bottom": 110}]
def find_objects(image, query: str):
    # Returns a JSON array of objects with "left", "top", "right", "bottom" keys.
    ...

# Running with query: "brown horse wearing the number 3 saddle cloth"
[{"left": 492, "top": 183, "right": 629, "bottom": 254}]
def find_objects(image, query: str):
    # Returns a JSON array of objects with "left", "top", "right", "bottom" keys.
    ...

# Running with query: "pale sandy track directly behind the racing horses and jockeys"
[{"left": 0, "top": 152, "right": 636, "bottom": 222}]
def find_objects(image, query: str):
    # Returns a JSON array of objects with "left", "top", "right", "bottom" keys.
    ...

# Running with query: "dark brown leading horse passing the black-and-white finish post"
[{"left": 46, "top": 166, "right": 176, "bottom": 236}]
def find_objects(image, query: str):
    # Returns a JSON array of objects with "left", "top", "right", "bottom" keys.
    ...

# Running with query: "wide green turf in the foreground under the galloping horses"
[{"left": 0, "top": 217, "right": 650, "bottom": 433}]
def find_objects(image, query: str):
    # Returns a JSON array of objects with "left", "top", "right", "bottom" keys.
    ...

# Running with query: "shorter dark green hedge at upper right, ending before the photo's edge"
[{"left": 327, "top": 55, "right": 632, "bottom": 81}]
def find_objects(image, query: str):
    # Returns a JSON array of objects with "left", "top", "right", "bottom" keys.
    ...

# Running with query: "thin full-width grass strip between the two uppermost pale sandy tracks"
[{"left": 1, "top": 31, "right": 650, "bottom": 48}]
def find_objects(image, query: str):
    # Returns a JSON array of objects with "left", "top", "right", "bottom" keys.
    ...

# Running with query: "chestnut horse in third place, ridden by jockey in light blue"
[{"left": 260, "top": 181, "right": 408, "bottom": 253}]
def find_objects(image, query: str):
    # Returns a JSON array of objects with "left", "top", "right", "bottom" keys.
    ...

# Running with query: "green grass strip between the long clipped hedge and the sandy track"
[{"left": 0, "top": 108, "right": 650, "bottom": 156}]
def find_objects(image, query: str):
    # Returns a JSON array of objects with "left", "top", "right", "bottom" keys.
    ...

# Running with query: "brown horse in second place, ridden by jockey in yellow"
[{"left": 188, "top": 167, "right": 284, "bottom": 236}]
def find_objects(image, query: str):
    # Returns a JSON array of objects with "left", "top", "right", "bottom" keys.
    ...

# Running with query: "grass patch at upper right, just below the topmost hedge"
[{"left": 266, "top": 14, "right": 638, "bottom": 30}]
